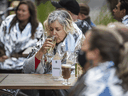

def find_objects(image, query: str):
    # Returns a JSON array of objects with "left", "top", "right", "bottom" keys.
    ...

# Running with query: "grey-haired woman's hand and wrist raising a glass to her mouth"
[{"left": 35, "top": 38, "right": 55, "bottom": 60}]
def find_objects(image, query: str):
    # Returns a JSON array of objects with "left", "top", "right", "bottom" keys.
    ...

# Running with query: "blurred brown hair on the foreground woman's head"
[{"left": 90, "top": 26, "right": 121, "bottom": 68}]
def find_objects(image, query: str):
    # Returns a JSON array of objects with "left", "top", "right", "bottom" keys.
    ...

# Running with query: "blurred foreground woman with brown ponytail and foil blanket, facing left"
[{"left": 65, "top": 26, "right": 128, "bottom": 96}]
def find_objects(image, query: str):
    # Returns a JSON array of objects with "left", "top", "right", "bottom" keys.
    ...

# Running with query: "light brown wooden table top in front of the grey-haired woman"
[{"left": 0, "top": 74, "right": 77, "bottom": 89}]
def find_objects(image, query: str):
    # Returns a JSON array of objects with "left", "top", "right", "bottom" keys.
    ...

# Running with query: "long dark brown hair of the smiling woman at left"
[{"left": 9, "top": 0, "right": 39, "bottom": 38}]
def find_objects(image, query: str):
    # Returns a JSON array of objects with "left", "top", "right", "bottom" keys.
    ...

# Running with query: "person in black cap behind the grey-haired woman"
[{"left": 51, "top": 0, "right": 88, "bottom": 34}]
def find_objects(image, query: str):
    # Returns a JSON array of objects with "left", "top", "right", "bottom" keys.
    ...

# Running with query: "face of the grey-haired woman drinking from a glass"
[{"left": 49, "top": 20, "right": 66, "bottom": 43}]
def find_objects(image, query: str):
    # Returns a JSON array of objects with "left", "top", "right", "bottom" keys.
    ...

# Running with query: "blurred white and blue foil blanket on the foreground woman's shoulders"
[{"left": 79, "top": 61, "right": 128, "bottom": 96}]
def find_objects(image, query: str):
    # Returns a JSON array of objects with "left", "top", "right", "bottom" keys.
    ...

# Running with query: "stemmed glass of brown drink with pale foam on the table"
[{"left": 61, "top": 64, "right": 71, "bottom": 85}]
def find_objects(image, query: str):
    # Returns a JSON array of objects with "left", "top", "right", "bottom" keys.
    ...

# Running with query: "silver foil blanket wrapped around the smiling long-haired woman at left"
[{"left": 0, "top": 15, "right": 43, "bottom": 69}]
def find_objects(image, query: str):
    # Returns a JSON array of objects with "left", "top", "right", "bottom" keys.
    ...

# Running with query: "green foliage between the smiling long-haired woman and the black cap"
[{"left": 37, "top": 1, "right": 55, "bottom": 24}]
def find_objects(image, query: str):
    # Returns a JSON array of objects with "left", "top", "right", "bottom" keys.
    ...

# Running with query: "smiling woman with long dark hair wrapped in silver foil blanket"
[{"left": 0, "top": 0, "right": 43, "bottom": 73}]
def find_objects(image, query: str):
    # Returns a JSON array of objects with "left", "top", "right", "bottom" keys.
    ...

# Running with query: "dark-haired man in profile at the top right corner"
[{"left": 113, "top": 0, "right": 128, "bottom": 26}]
